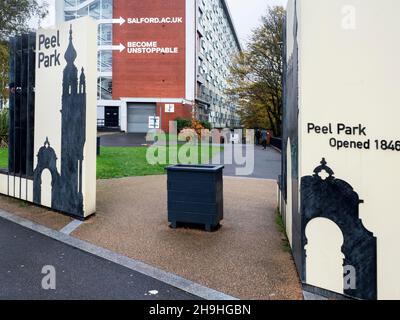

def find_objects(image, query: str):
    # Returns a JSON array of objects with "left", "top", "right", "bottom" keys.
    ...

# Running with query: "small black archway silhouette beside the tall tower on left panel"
[{"left": 33, "top": 138, "right": 61, "bottom": 210}]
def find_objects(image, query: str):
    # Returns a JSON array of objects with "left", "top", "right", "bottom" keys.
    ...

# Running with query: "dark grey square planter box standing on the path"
[{"left": 166, "top": 165, "right": 224, "bottom": 231}]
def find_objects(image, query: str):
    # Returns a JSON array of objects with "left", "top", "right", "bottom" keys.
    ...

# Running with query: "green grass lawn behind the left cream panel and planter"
[{"left": 0, "top": 145, "right": 223, "bottom": 179}]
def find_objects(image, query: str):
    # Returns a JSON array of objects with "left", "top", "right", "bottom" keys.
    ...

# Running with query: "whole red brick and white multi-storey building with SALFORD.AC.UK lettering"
[{"left": 57, "top": 0, "right": 240, "bottom": 133}]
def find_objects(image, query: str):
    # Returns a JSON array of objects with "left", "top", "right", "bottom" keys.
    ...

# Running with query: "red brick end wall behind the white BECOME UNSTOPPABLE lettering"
[{"left": 113, "top": 0, "right": 186, "bottom": 100}]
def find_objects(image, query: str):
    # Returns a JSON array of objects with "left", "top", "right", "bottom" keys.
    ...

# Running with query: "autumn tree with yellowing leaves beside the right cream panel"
[{"left": 227, "top": 6, "right": 285, "bottom": 136}]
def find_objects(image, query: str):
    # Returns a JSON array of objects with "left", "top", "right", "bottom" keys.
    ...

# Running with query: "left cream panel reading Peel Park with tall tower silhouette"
[{"left": 33, "top": 17, "right": 97, "bottom": 217}]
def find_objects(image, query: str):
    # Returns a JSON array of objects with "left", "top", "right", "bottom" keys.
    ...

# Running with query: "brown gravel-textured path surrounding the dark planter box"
[{"left": 72, "top": 176, "right": 302, "bottom": 299}]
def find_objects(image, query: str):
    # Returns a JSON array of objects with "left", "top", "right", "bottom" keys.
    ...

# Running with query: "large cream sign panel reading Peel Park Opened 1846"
[{"left": 282, "top": 0, "right": 400, "bottom": 299}]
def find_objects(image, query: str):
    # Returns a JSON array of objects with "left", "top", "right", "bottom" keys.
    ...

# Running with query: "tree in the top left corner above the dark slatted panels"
[{"left": 0, "top": 0, "right": 48, "bottom": 104}]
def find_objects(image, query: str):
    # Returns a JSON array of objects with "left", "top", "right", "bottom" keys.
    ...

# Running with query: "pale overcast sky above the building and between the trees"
[{"left": 40, "top": 0, "right": 287, "bottom": 45}]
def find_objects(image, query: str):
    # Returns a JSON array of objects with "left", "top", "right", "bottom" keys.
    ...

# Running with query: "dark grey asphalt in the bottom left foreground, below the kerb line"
[{"left": 0, "top": 218, "right": 198, "bottom": 300}]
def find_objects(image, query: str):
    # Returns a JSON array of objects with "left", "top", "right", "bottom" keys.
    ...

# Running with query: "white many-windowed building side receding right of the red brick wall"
[{"left": 196, "top": 0, "right": 241, "bottom": 127}]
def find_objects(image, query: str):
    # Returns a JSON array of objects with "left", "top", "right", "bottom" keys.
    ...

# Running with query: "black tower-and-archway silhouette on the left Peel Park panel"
[{"left": 33, "top": 26, "right": 86, "bottom": 217}]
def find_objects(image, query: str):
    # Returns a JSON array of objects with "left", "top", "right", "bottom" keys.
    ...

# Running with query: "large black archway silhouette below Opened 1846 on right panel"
[{"left": 301, "top": 159, "right": 377, "bottom": 300}]
